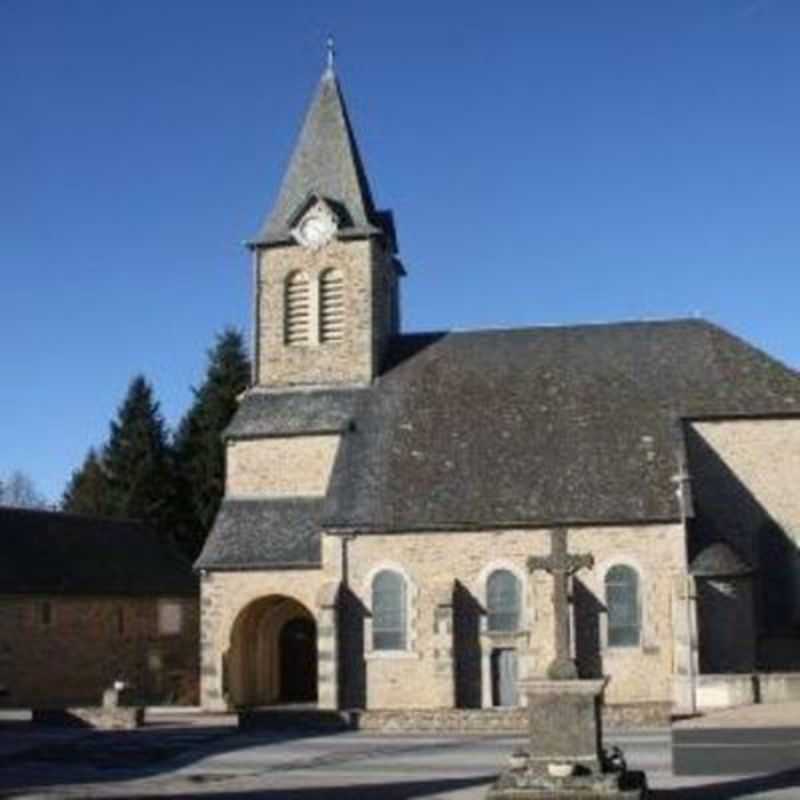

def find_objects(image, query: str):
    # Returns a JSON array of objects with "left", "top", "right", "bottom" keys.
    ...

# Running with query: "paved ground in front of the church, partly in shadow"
[{"left": 0, "top": 705, "right": 800, "bottom": 800}]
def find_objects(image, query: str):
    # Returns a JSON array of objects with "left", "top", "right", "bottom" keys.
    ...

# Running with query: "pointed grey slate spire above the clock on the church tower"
[{"left": 253, "top": 50, "right": 380, "bottom": 245}]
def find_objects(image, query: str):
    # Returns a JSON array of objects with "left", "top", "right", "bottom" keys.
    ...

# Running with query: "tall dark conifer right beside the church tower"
[{"left": 170, "top": 328, "right": 250, "bottom": 559}]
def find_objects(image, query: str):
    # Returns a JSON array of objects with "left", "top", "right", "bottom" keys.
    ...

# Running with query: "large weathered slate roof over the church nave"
[{"left": 323, "top": 320, "right": 800, "bottom": 532}]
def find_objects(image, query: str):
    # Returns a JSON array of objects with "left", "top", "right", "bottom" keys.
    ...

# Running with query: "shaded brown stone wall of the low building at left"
[{"left": 0, "top": 595, "right": 199, "bottom": 708}]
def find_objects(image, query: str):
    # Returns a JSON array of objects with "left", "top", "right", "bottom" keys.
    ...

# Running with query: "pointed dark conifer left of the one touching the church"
[{"left": 102, "top": 375, "right": 171, "bottom": 529}]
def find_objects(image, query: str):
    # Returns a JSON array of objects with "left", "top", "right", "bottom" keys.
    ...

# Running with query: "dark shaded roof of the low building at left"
[{"left": 0, "top": 507, "right": 198, "bottom": 597}]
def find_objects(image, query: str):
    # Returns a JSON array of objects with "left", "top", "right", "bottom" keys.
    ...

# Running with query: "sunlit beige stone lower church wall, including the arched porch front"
[{"left": 202, "top": 525, "right": 686, "bottom": 709}]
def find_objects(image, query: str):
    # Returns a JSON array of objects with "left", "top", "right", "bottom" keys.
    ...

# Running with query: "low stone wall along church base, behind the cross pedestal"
[{"left": 355, "top": 703, "right": 672, "bottom": 734}]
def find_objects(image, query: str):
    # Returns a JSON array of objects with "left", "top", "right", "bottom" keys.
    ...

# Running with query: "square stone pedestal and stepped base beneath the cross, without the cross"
[{"left": 487, "top": 679, "right": 647, "bottom": 800}]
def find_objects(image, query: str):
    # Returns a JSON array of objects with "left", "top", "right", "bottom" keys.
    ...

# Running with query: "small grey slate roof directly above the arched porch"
[{"left": 195, "top": 497, "right": 323, "bottom": 569}]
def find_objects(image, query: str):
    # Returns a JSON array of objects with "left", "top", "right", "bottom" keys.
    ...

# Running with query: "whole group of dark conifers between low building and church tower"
[{"left": 61, "top": 329, "right": 250, "bottom": 560}]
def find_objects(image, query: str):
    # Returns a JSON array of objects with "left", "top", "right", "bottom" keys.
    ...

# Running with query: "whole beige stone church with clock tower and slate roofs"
[{"left": 196, "top": 57, "right": 800, "bottom": 716}]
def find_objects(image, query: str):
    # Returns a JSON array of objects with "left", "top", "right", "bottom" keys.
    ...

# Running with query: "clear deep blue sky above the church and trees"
[{"left": 0, "top": 0, "right": 800, "bottom": 499}]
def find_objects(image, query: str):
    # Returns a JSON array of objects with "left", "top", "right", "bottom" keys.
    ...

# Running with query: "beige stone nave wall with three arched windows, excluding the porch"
[{"left": 342, "top": 525, "right": 685, "bottom": 709}]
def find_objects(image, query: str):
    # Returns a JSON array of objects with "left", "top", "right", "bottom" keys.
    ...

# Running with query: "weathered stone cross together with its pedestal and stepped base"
[{"left": 487, "top": 529, "right": 647, "bottom": 800}]
